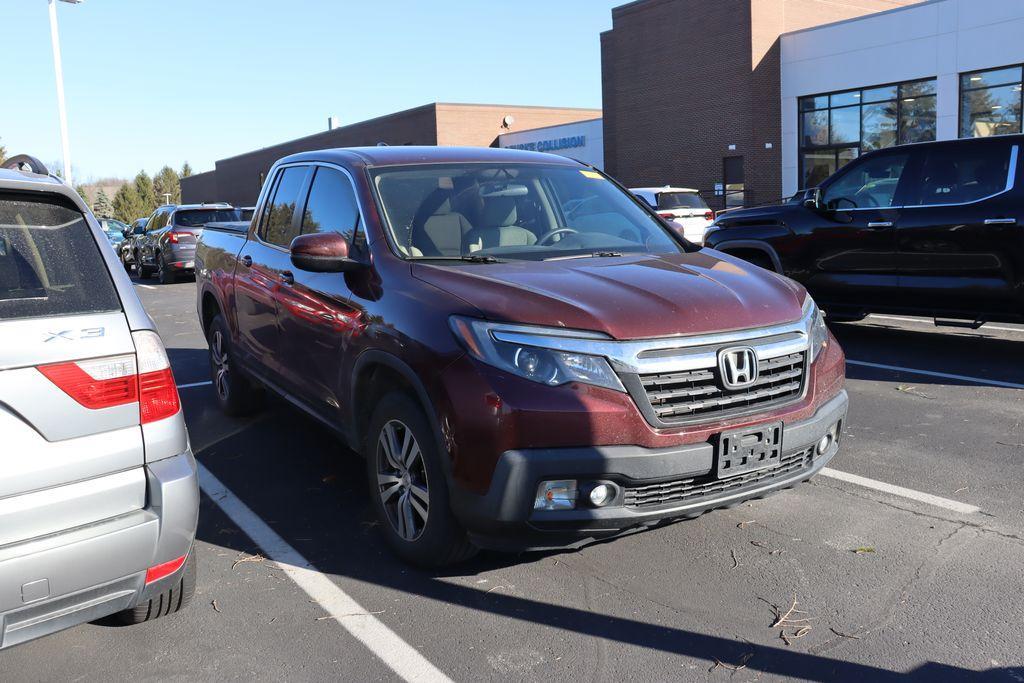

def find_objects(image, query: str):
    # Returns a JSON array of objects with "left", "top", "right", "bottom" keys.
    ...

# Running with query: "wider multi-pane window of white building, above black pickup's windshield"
[{"left": 800, "top": 79, "right": 935, "bottom": 187}]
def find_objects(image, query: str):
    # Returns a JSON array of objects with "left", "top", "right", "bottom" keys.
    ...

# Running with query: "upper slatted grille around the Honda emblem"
[{"left": 640, "top": 352, "right": 805, "bottom": 423}]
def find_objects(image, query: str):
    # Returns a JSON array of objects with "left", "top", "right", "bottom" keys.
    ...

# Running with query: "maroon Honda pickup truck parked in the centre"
[{"left": 196, "top": 146, "right": 847, "bottom": 565}]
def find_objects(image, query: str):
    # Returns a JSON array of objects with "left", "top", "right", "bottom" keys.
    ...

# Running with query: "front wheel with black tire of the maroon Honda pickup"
[{"left": 364, "top": 393, "right": 477, "bottom": 567}]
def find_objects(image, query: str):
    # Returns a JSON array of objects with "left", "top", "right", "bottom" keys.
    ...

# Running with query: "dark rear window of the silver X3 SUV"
[{"left": 0, "top": 196, "right": 121, "bottom": 321}]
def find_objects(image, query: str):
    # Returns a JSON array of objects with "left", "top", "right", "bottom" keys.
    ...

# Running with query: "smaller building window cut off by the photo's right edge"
[{"left": 961, "top": 67, "right": 1024, "bottom": 137}]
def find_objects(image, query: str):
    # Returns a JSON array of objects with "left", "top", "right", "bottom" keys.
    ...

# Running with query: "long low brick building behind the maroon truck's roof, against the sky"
[{"left": 181, "top": 102, "right": 601, "bottom": 206}]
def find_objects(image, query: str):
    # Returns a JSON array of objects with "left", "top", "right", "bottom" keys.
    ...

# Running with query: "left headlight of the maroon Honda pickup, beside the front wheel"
[{"left": 450, "top": 315, "right": 626, "bottom": 393}]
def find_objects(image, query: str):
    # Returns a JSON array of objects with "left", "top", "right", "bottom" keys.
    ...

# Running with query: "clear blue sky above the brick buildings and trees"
[{"left": 0, "top": 0, "right": 626, "bottom": 181}]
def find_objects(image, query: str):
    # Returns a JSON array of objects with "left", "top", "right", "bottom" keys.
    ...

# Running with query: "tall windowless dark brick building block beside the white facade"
[{"left": 601, "top": 0, "right": 918, "bottom": 208}]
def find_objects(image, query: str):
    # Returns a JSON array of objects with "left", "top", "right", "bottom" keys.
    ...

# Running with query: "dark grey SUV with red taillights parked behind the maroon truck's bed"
[{"left": 133, "top": 204, "right": 239, "bottom": 285}]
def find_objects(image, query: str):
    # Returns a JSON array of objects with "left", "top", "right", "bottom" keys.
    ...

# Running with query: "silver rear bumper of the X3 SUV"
[{"left": 0, "top": 451, "right": 199, "bottom": 650}]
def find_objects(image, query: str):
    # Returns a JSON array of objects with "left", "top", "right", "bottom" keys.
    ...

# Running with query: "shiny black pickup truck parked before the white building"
[{"left": 706, "top": 135, "right": 1024, "bottom": 325}]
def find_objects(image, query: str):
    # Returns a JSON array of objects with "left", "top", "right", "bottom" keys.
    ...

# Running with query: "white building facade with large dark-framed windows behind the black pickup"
[{"left": 778, "top": 0, "right": 1024, "bottom": 196}]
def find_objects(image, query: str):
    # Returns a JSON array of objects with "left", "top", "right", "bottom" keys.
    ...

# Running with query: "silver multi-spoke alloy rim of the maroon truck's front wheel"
[{"left": 377, "top": 420, "right": 430, "bottom": 541}]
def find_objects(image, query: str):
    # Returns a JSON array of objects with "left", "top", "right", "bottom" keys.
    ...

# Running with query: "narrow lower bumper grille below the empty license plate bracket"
[{"left": 623, "top": 446, "right": 814, "bottom": 508}]
